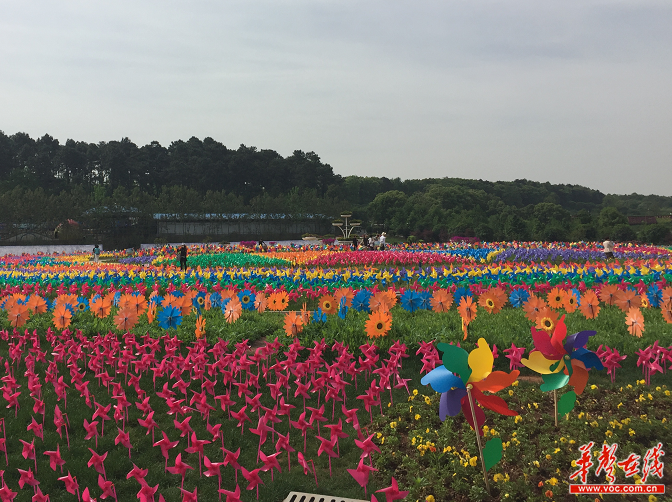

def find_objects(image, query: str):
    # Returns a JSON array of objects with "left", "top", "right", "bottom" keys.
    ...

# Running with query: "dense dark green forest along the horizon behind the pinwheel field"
[{"left": 0, "top": 131, "right": 672, "bottom": 243}]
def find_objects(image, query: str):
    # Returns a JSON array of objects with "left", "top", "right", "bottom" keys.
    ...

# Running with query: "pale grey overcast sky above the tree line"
[{"left": 0, "top": 0, "right": 672, "bottom": 195}]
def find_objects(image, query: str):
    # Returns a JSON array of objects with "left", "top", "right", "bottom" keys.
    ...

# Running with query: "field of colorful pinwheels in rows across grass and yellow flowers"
[{"left": 0, "top": 242, "right": 672, "bottom": 502}]
